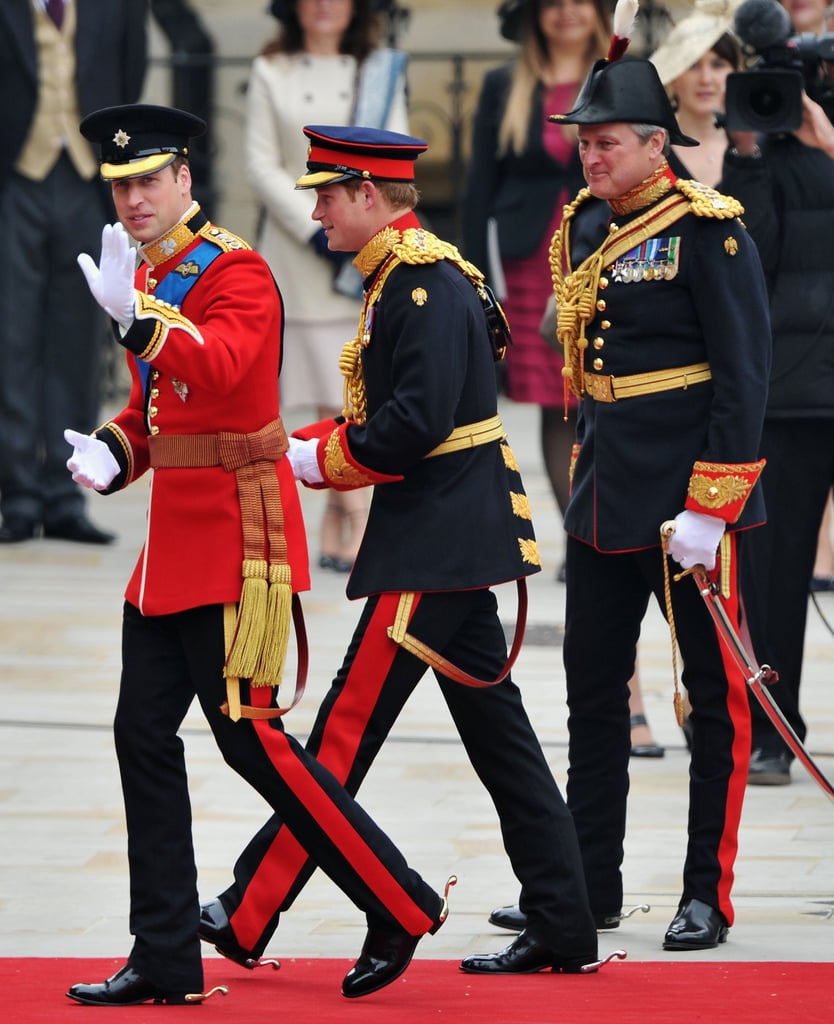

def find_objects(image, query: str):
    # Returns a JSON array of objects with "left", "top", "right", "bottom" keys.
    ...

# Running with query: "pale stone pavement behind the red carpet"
[{"left": 0, "top": 401, "right": 834, "bottom": 962}]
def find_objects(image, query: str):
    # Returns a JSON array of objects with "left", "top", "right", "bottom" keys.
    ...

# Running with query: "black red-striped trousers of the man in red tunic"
[{"left": 115, "top": 604, "right": 442, "bottom": 991}]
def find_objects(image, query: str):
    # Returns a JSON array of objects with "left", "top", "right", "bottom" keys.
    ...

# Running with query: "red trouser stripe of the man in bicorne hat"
[{"left": 716, "top": 534, "right": 751, "bottom": 925}]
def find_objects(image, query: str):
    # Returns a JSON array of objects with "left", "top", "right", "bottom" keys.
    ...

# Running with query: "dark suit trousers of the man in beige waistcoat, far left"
[{"left": 0, "top": 156, "right": 107, "bottom": 523}]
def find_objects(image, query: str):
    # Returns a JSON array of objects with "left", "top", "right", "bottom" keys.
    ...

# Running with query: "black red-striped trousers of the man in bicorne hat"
[{"left": 564, "top": 534, "right": 750, "bottom": 924}]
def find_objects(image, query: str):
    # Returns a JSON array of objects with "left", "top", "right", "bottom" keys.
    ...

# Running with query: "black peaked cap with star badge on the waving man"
[{"left": 80, "top": 103, "right": 206, "bottom": 181}]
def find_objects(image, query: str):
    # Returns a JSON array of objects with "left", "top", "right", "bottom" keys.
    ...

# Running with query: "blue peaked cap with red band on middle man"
[{"left": 295, "top": 125, "right": 428, "bottom": 188}]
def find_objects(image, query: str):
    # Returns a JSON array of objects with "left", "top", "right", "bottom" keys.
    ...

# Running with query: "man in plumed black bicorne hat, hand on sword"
[{"left": 485, "top": 4, "right": 770, "bottom": 950}]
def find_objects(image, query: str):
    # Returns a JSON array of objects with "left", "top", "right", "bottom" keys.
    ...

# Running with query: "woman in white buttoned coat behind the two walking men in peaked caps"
[{"left": 246, "top": 0, "right": 408, "bottom": 571}]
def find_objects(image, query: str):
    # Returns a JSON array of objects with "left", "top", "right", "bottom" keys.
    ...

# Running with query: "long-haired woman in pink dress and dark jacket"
[{"left": 463, "top": 0, "right": 611, "bottom": 561}]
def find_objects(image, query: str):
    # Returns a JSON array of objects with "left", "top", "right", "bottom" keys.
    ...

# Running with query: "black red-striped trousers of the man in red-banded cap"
[{"left": 212, "top": 590, "right": 596, "bottom": 958}]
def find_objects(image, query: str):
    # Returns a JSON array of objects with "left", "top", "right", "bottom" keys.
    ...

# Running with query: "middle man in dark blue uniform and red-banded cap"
[{"left": 201, "top": 121, "right": 597, "bottom": 973}]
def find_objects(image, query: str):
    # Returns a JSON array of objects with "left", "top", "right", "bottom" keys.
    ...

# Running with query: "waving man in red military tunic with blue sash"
[{"left": 67, "top": 105, "right": 446, "bottom": 1005}]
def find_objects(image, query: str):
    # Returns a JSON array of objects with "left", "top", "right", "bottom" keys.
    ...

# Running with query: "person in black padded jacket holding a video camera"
[{"left": 722, "top": 0, "right": 834, "bottom": 785}]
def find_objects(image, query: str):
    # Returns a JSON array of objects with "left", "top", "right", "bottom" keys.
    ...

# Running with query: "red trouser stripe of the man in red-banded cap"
[{"left": 231, "top": 594, "right": 420, "bottom": 949}]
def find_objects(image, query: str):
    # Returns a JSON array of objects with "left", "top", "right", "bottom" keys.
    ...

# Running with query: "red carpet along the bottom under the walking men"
[{"left": 0, "top": 958, "right": 834, "bottom": 1024}]
